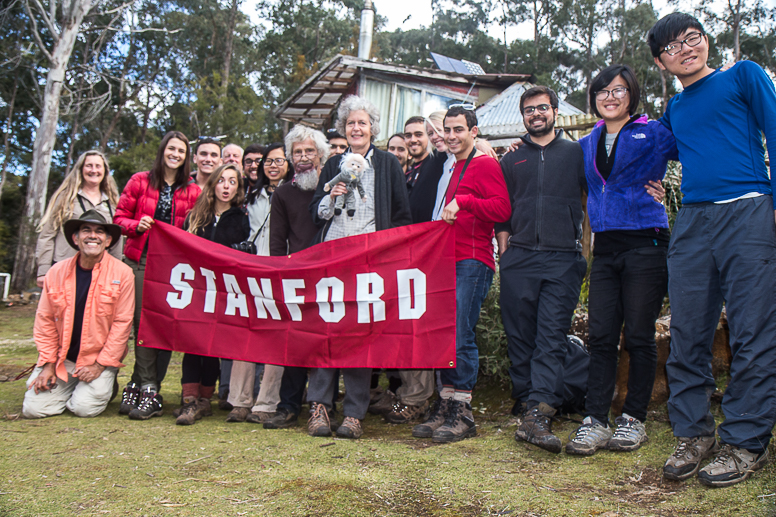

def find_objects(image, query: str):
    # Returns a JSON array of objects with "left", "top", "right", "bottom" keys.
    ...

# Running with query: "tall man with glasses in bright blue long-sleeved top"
[{"left": 648, "top": 13, "right": 776, "bottom": 487}]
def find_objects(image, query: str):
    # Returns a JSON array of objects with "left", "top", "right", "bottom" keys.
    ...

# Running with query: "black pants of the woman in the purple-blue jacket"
[{"left": 585, "top": 246, "right": 668, "bottom": 422}]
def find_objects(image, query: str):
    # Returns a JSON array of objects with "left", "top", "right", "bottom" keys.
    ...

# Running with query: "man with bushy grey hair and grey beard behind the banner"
[{"left": 262, "top": 124, "right": 329, "bottom": 429}]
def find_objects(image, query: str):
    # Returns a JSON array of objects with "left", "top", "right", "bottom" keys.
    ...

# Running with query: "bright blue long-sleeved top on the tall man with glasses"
[{"left": 660, "top": 61, "right": 776, "bottom": 209}]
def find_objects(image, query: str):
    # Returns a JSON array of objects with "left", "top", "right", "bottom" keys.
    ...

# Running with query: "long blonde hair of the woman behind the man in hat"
[{"left": 38, "top": 150, "right": 119, "bottom": 232}]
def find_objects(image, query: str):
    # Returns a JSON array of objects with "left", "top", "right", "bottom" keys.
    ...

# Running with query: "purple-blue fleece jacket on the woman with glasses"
[{"left": 579, "top": 115, "right": 678, "bottom": 233}]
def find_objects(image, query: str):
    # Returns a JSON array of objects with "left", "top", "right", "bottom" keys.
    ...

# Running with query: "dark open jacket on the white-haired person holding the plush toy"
[{"left": 309, "top": 146, "right": 412, "bottom": 242}]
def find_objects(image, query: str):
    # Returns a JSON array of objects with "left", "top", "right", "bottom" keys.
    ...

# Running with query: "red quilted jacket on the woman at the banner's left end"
[{"left": 113, "top": 171, "right": 202, "bottom": 262}]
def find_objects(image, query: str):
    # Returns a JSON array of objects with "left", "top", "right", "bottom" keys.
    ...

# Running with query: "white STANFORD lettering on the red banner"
[{"left": 166, "top": 263, "right": 427, "bottom": 323}]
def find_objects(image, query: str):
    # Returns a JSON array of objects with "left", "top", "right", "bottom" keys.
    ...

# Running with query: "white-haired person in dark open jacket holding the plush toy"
[{"left": 307, "top": 96, "right": 412, "bottom": 438}]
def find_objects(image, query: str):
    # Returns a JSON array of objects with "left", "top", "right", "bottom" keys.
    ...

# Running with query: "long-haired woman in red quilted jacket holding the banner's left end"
[{"left": 113, "top": 131, "right": 201, "bottom": 420}]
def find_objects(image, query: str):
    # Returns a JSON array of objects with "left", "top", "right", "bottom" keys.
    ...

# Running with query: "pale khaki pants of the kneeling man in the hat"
[{"left": 22, "top": 361, "right": 118, "bottom": 418}]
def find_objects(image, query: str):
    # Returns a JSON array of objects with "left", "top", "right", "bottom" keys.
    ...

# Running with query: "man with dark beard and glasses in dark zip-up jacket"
[{"left": 495, "top": 86, "right": 587, "bottom": 453}]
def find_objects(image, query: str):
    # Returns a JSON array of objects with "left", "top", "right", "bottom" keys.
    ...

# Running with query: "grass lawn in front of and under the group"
[{"left": 0, "top": 306, "right": 776, "bottom": 517}]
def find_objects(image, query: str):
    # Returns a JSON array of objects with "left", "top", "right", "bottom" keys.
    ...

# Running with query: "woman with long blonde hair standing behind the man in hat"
[{"left": 35, "top": 151, "right": 123, "bottom": 287}]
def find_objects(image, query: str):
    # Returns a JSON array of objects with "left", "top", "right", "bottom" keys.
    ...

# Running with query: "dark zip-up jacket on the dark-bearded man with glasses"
[{"left": 495, "top": 129, "right": 587, "bottom": 251}]
